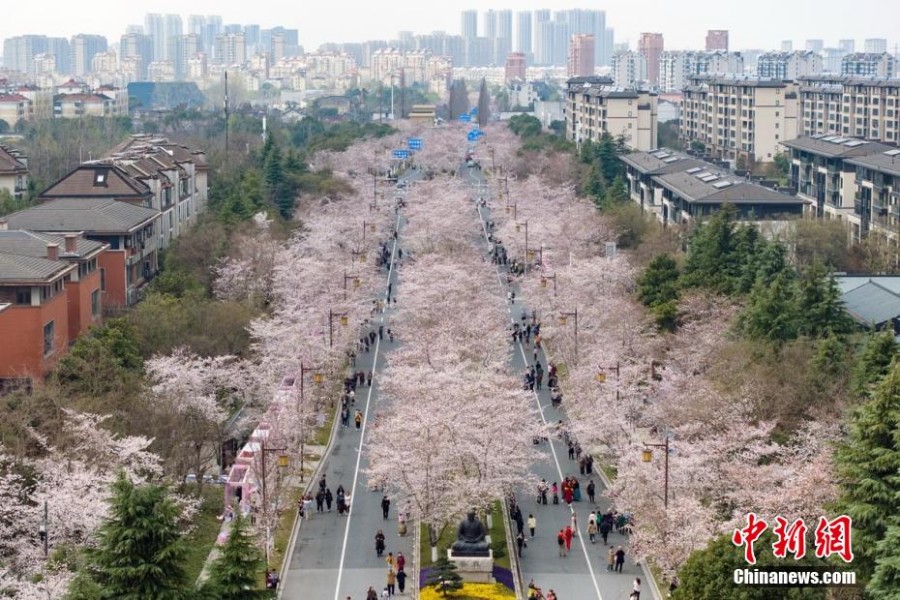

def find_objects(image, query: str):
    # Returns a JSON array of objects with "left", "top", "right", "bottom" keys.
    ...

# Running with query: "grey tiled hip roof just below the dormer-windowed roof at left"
[{"left": 7, "top": 198, "right": 159, "bottom": 234}]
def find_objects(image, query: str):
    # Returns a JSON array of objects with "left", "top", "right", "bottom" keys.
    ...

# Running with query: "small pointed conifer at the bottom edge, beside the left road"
[{"left": 204, "top": 515, "right": 272, "bottom": 600}]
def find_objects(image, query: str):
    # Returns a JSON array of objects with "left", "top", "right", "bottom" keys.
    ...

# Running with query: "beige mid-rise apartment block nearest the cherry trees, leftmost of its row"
[{"left": 565, "top": 77, "right": 657, "bottom": 150}]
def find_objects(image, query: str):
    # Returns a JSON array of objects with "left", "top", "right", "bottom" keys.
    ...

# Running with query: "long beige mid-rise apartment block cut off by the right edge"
[{"left": 798, "top": 76, "right": 900, "bottom": 144}]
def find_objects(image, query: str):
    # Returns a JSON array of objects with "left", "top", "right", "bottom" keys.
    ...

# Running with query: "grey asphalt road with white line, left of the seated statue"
[{"left": 281, "top": 171, "right": 419, "bottom": 600}]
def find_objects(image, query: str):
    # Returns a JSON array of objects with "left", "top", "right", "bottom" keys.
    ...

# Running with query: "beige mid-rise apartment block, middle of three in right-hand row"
[{"left": 681, "top": 75, "right": 799, "bottom": 165}]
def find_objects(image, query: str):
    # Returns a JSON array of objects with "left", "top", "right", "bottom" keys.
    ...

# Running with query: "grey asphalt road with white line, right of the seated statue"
[{"left": 468, "top": 165, "right": 654, "bottom": 600}]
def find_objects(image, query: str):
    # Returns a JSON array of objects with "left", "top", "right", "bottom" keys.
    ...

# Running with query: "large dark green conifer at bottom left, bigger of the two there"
[{"left": 69, "top": 474, "right": 193, "bottom": 600}]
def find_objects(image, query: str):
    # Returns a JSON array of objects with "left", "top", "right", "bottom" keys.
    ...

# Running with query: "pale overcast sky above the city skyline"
[{"left": 0, "top": 0, "right": 900, "bottom": 51}]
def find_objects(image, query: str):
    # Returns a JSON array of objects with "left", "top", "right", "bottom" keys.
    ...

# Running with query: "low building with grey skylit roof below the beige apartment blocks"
[{"left": 620, "top": 148, "right": 804, "bottom": 225}]
